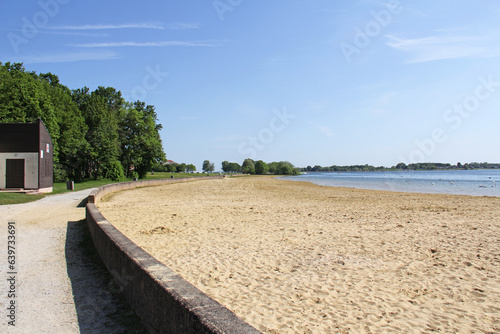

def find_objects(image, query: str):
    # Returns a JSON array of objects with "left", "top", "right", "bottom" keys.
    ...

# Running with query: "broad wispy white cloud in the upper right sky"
[{"left": 386, "top": 35, "right": 500, "bottom": 63}]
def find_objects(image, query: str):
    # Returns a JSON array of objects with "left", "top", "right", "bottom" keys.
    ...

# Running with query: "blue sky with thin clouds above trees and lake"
[{"left": 0, "top": 0, "right": 500, "bottom": 169}]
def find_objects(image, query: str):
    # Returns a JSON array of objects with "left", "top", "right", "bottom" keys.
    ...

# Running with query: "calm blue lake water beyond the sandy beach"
[{"left": 283, "top": 169, "right": 500, "bottom": 197}]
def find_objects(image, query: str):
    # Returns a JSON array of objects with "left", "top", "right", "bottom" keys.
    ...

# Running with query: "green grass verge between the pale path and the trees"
[{"left": 0, "top": 172, "right": 223, "bottom": 205}]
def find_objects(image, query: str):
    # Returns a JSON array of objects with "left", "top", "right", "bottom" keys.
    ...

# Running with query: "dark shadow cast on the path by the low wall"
[{"left": 65, "top": 220, "right": 147, "bottom": 334}]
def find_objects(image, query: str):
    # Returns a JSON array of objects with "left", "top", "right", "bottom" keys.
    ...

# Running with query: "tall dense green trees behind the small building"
[{"left": 0, "top": 62, "right": 165, "bottom": 182}]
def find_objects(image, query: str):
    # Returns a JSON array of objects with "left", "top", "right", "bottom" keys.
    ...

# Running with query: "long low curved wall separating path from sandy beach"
[{"left": 86, "top": 176, "right": 260, "bottom": 334}]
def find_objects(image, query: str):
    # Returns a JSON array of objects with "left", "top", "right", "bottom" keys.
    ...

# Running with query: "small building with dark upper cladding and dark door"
[{"left": 0, "top": 119, "right": 54, "bottom": 192}]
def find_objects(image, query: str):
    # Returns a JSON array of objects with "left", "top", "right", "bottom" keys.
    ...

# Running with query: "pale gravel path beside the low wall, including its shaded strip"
[{"left": 0, "top": 189, "right": 143, "bottom": 334}]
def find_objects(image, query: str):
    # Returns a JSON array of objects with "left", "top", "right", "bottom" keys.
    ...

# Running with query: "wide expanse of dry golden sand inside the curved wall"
[{"left": 99, "top": 177, "right": 500, "bottom": 333}]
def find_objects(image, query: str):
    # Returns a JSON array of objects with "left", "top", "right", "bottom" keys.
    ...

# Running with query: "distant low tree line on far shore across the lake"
[{"left": 300, "top": 162, "right": 500, "bottom": 172}]
